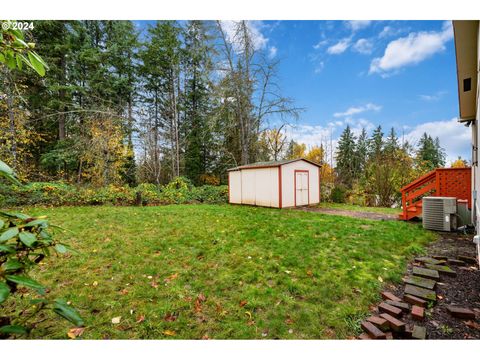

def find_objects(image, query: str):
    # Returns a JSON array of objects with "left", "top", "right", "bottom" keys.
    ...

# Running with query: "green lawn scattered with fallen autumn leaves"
[{"left": 4, "top": 205, "right": 435, "bottom": 339}]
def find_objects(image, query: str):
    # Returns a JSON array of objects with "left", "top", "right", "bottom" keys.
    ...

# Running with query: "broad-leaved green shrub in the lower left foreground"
[{"left": 0, "top": 161, "right": 84, "bottom": 338}]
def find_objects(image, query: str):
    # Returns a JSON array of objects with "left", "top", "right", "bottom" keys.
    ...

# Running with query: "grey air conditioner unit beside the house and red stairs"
[{"left": 422, "top": 196, "right": 457, "bottom": 231}]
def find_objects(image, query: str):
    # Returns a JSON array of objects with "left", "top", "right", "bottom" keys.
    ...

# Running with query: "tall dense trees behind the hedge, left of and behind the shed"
[{"left": 0, "top": 20, "right": 301, "bottom": 186}]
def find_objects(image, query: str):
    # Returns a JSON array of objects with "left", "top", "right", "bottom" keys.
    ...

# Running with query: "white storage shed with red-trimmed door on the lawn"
[{"left": 228, "top": 159, "right": 321, "bottom": 208}]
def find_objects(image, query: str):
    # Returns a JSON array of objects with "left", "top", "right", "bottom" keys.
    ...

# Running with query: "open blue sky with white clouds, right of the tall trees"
[{"left": 251, "top": 21, "right": 471, "bottom": 161}]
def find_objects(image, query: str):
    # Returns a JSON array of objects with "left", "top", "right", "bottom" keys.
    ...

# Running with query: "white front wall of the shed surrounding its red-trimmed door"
[{"left": 281, "top": 160, "right": 320, "bottom": 207}]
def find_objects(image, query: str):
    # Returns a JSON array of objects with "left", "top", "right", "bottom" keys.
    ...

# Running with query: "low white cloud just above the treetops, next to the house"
[{"left": 405, "top": 118, "right": 471, "bottom": 165}]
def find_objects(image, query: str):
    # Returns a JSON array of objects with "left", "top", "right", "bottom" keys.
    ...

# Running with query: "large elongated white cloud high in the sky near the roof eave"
[{"left": 369, "top": 21, "right": 453, "bottom": 75}]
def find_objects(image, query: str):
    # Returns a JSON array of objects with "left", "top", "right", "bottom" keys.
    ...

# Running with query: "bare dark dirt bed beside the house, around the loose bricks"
[{"left": 376, "top": 233, "right": 480, "bottom": 339}]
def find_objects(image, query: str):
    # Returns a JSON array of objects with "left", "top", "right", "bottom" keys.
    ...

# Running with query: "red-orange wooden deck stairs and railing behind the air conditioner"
[{"left": 400, "top": 168, "right": 472, "bottom": 220}]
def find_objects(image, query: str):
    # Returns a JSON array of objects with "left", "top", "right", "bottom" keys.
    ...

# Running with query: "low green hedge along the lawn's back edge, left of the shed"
[{"left": 0, "top": 177, "right": 228, "bottom": 208}]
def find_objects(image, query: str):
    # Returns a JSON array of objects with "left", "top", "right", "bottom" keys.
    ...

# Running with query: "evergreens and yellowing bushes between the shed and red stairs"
[{"left": 335, "top": 126, "right": 448, "bottom": 206}]
